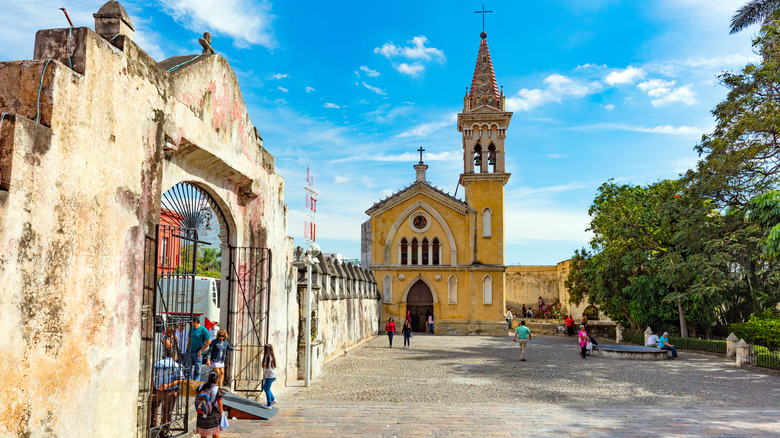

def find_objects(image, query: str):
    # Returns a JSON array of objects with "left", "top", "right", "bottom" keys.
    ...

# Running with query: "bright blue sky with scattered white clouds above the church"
[{"left": 0, "top": 0, "right": 757, "bottom": 265}]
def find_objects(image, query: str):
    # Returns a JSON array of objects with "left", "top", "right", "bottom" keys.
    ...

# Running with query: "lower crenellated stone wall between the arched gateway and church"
[{"left": 293, "top": 248, "right": 381, "bottom": 379}]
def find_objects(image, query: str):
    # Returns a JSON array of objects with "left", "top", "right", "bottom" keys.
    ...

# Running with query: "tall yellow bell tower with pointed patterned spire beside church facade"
[{"left": 458, "top": 31, "right": 512, "bottom": 265}]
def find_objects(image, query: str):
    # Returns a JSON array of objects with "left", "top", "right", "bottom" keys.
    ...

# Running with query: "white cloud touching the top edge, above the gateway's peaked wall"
[{"left": 159, "top": 0, "right": 277, "bottom": 49}]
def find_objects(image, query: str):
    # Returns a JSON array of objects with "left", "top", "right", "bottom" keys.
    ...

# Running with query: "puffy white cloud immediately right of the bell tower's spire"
[{"left": 506, "top": 73, "right": 604, "bottom": 111}]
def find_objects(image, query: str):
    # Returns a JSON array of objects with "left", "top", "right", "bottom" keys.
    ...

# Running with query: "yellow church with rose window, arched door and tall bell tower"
[{"left": 362, "top": 32, "right": 512, "bottom": 335}]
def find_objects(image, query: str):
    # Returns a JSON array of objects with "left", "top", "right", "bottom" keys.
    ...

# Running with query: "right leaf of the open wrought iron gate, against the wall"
[{"left": 227, "top": 247, "right": 271, "bottom": 392}]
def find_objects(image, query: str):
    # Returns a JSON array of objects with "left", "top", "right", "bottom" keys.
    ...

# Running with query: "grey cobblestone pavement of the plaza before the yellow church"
[{"left": 222, "top": 334, "right": 780, "bottom": 437}]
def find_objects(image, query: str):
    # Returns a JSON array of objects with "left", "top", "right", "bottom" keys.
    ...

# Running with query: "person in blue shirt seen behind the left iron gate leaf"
[{"left": 150, "top": 348, "right": 185, "bottom": 437}]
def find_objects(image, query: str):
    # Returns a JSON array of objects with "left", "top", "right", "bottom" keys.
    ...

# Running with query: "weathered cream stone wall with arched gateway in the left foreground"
[{"left": 0, "top": 22, "right": 298, "bottom": 436}]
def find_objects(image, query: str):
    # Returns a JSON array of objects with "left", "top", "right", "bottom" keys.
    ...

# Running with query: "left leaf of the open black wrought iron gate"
[{"left": 138, "top": 225, "right": 200, "bottom": 438}]
